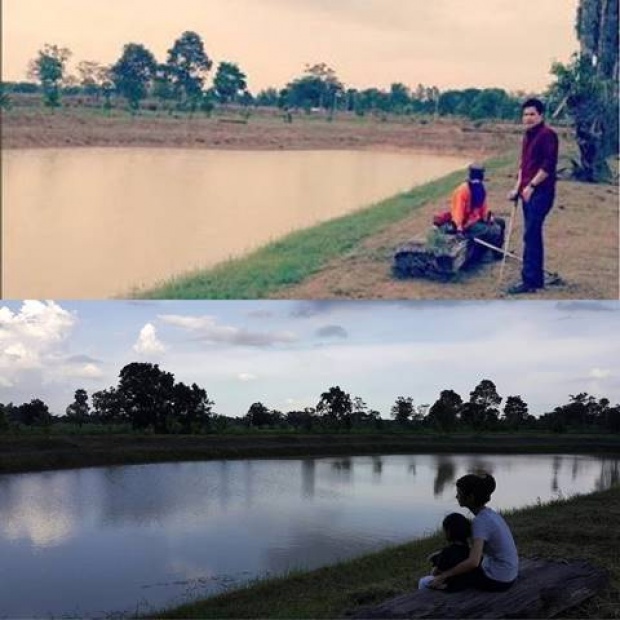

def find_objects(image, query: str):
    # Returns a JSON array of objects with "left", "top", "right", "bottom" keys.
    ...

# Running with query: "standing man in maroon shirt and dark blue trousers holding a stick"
[{"left": 508, "top": 99, "right": 558, "bottom": 295}]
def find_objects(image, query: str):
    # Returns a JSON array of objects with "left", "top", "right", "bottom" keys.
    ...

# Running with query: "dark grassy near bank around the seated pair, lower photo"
[{"left": 151, "top": 486, "right": 620, "bottom": 618}]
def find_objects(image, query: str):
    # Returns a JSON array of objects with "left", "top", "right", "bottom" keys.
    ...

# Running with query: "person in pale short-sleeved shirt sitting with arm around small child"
[{"left": 429, "top": 474, "right": 519, "bottom": 592}]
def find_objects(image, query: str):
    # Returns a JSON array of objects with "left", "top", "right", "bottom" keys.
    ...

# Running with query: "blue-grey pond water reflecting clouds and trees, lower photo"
[{"left": 0, "top": 455, "right": 620, "bottom": 617}]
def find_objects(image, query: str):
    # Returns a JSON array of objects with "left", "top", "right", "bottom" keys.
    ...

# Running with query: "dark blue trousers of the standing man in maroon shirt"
[{"left": 521, "top": 188, "right": 555, "bottom": 288}]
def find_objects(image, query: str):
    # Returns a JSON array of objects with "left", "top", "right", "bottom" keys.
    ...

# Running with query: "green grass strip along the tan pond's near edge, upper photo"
[{"left": 138, "top": 153, "right": 515, "bottom": 299}]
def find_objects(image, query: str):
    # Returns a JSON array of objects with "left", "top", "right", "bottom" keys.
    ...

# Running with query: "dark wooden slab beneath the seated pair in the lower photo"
[{"left": 351, "top": 558, "right": 609, "bottom": 619}]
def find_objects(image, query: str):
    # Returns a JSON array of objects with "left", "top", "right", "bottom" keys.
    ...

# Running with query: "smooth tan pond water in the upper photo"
[{"left": 2, "top": 149, "right": 467, "bottom": 299}]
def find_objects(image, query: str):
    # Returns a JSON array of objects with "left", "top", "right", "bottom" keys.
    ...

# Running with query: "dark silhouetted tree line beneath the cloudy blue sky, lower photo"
[{"left": 0, "top": 362, "right": 620, "bottom": 434}]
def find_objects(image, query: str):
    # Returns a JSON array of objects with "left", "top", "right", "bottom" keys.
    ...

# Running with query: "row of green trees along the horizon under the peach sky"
[{"left": 2, "top": 31, "right": 524, "bottom": 120}]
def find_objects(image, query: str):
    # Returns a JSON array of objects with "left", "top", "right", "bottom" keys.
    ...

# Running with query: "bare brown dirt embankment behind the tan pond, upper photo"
[{"left": 2, "top": 107, "right": 520, "bottom": 156}]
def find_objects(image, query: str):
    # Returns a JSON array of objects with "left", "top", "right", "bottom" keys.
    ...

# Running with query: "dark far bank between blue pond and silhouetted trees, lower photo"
[{"left": 0, "top": 432, "right": 620, "bottom": 473}]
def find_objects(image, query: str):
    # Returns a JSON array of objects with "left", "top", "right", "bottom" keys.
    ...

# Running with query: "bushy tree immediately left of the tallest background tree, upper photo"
[{"left": 110, "top": 43, "right": 157, "bottom": 113}]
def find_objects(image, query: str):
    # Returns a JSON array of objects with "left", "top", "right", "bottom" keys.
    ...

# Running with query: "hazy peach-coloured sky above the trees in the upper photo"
[{"left": 2, "top": 0, "right": 578, "bottom": 94}]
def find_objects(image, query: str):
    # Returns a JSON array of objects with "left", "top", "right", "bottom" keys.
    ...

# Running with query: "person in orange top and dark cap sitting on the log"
[{"left": 450, "top": 164, "right": 504, "bottom": 258}]
